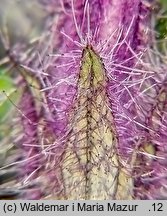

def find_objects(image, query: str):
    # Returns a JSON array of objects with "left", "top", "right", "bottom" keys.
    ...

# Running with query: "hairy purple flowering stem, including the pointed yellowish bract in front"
[{"left": 5, "top": 0, "right": 167, "bottom": 199}]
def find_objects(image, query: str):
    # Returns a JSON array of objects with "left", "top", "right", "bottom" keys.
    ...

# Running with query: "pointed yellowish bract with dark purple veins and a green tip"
[{"left": 57, "top": 47, "right": 132, "bottom": 200}]
